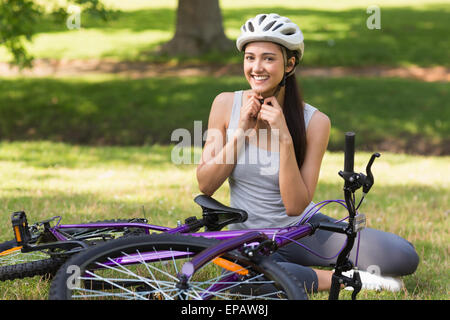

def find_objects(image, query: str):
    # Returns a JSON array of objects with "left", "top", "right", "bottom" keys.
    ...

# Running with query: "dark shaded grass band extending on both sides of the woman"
[{"left": 0, "top": 76, "right": 450, "bottom": 154}]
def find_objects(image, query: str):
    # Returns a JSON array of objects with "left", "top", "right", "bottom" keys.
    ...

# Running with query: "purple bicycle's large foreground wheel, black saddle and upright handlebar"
[{"left": 45, "top": 133, "right": 380, "bottom": 300}]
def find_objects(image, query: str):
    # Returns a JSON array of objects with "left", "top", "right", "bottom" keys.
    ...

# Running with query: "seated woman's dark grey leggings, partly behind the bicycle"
[{"left": 273, "top": 213, "right": 419, "bottom": 292}]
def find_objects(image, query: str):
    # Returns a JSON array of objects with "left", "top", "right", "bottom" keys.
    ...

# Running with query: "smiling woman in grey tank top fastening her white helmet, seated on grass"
[{"left": 197, "top": 13, "right": 418, "bottom": 298}]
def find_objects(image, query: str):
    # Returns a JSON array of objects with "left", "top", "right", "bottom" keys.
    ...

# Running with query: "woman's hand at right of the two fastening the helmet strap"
[{"left": 258, "top": 97, "right": 292, "bottom": 143}]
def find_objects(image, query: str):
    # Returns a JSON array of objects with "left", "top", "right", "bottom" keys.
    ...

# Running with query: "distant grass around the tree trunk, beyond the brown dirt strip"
[{"left": 0, "top": 0, "right": 450, "bottom": 66}]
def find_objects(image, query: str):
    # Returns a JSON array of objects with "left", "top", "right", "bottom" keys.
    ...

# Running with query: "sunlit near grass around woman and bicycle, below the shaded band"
[{"left": 0, "top": 142, "right": 450, "bottom": 299}]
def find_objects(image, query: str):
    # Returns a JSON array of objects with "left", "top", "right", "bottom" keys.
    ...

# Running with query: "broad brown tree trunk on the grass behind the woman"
[{"left": 161, "top": 0, "right": 234, "bottom": 56}]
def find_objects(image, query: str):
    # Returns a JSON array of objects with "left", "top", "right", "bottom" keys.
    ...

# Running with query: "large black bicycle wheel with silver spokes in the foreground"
[{"left": 49, "top": 234, "right": 307, "bottom": 300}]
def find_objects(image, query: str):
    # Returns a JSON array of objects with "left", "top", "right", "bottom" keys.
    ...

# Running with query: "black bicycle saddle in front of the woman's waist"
[{"left": 194, "top": 194, "right": 248, "bottom": 231}]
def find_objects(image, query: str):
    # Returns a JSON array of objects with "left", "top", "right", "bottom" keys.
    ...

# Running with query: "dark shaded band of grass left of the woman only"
[{"left": 0, "top": 78, "right": 242, "bottom": 145}]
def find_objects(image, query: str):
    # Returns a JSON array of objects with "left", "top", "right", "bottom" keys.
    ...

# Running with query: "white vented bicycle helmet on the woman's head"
[{"left": 236, "top": 13, "right": 304, "bottom": 59}]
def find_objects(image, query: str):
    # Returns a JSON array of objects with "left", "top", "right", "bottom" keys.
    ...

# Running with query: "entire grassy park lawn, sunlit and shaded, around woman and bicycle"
[{"left": 0, "top": 0, "right": 450, "bottom": 299}]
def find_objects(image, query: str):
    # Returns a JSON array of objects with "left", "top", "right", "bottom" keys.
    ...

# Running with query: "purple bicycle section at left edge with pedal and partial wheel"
[{"left": 0, "top": 215, "right": 153, "bottom": 281}]
